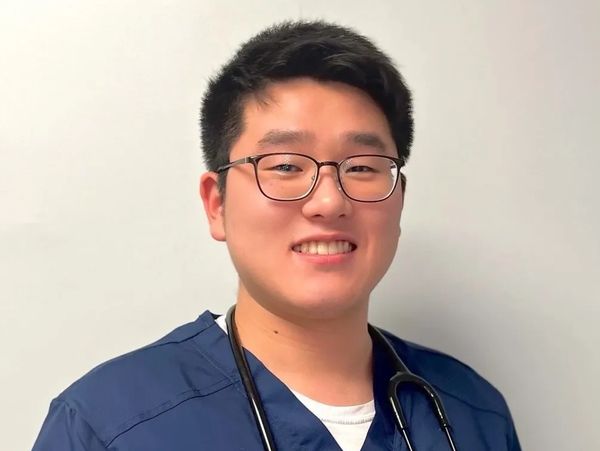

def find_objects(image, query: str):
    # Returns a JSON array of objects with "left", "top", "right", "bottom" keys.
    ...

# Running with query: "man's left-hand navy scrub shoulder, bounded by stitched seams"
[{"left": 54, "top": 312, "right": 232, "bottom": 445}]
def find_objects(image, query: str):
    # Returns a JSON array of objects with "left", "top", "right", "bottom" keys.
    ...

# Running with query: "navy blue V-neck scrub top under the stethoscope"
[{"left": 33, "top": 311, "right": 521, "bottom": 451}]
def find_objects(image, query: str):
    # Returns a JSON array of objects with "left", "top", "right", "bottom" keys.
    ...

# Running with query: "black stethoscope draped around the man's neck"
[{"left": 225, "top": 306, "right": 456, "bottom": 451}]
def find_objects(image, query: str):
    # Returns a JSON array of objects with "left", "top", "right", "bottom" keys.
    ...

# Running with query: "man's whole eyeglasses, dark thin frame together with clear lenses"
[{"left": 216, "top": 153, "right": 406, "bottom": 202}]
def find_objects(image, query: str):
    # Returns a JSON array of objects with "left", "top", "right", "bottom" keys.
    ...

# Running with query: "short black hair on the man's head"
[{"left": 200, "top": 21, "right": 413, "bottom": 191}]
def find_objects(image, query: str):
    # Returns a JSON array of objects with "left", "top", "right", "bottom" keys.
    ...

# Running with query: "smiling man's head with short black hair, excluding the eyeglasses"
[{"left": 201, "top": 22, "right": 413, "bottom": 318}]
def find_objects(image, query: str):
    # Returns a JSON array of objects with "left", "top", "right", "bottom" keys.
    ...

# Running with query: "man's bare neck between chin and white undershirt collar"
[{"left": 235, "top": 287, "right": 373, "bottom": 405}]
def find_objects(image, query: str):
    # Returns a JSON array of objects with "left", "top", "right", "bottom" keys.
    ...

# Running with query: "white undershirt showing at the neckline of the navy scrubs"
[{"left": 215, "top": 315, "right": 375, "bottom": 451}]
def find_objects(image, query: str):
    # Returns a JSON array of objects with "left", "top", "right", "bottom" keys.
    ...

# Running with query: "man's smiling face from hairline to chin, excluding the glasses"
[{"left": 202, "top": 78, "right": 403, "bottom": 319}]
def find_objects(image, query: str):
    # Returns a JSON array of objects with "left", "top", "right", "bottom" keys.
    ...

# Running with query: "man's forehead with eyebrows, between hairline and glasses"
[{"left": 231, "top": 78, "right": 396, "bottom": 158}]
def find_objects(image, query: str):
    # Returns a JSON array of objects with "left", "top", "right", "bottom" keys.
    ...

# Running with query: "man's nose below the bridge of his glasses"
[{"left": 302, "top": 166, "right": 352, "bottom": 220}]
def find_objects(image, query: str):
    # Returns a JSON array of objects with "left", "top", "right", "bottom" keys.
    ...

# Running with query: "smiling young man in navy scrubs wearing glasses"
[{"left": 34, "top": 22, "right": 520, "bottom": 451}]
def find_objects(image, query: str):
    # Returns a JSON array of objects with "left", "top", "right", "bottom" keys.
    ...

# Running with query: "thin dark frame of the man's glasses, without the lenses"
[{"left": 215, "top": 152, "right": 406, "bottom": 203}]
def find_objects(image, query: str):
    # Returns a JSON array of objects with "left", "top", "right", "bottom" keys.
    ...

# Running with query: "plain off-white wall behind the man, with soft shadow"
[{"left": 0, "top": 0, "right": 600, "bottom": 450}]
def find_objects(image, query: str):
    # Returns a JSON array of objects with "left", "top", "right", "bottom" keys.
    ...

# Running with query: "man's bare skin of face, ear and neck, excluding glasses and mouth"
[{"left": 200, "top": 78, "right": 404, "bottom": 405}]
